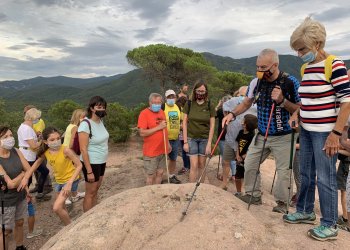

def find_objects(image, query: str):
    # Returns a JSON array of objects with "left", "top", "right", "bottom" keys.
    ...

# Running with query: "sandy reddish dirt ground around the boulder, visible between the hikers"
[{"left": 16, "top": 137, "right": 350, "bottom": 249}]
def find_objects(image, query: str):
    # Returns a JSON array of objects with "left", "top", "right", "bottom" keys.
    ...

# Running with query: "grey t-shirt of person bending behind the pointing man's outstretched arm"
[{"left": 222, "top": 97, "right": 257, "bottom": 151}]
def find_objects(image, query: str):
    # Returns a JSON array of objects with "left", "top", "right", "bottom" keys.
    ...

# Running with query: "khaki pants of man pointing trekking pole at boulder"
[{"left": 244, "top": 134, "right": 297, "bottom": 202}]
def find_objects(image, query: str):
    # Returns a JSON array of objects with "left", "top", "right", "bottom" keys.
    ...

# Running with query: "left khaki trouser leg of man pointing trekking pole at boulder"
[{"left": 244, "top": 134, "right": 270, "bottom": 197}]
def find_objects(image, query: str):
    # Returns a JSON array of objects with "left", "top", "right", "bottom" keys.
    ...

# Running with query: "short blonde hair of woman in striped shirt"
[{"left": 290, "top": 17, "right": 327, "bottom": 50}]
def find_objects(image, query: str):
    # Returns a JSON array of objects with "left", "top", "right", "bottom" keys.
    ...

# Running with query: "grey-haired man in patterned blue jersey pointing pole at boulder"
[{"left": 223, "top": 49, "right": 300, "bottom": 213}]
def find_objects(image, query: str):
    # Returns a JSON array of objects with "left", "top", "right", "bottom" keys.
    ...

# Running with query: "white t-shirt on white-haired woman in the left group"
[{"left": 17, "top": 123, "right": 38, "bottom": 161}]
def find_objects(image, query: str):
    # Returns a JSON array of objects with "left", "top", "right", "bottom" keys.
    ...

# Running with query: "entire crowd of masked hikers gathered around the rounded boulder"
[{"left": 0, "top": 18, "right": 350, "bottom": 249}]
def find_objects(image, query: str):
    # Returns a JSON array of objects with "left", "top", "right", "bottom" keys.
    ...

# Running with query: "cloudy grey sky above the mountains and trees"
[{"left": 0, "top": 0, "right": 350, "bottom": 81}]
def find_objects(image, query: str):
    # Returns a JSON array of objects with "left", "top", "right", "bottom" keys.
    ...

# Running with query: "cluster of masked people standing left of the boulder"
[{"left": 0, "top": 96, "right": 109, "bottom": 249}]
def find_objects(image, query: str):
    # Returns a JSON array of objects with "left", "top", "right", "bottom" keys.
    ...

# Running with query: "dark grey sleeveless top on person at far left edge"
[{"left": 0, "top": 148, "right": 26, "bottom": 207}]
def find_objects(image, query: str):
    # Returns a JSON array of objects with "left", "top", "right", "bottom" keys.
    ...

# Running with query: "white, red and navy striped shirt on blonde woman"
[{"left": 299, "top": 58, "right": 350, "bottom": 132}]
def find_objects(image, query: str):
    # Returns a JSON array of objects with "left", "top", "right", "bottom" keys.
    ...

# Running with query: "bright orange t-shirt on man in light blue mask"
[{"left": 137, "top": 108, "right": 168, "bottom": 157}]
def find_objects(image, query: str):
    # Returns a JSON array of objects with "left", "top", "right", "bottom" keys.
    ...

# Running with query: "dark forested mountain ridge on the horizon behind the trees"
[{"left": 0, "top": 53, "right": 350, "bottom": 110}]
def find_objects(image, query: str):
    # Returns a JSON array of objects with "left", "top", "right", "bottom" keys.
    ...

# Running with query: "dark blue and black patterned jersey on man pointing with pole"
[{"left": 247, "top": 72, "right": 300, "bottom": 135}]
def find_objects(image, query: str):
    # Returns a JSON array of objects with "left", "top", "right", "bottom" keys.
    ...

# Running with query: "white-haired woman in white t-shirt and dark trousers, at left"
[{"left": 17, "top": 108, "right": 51, "bottom": 201}]
